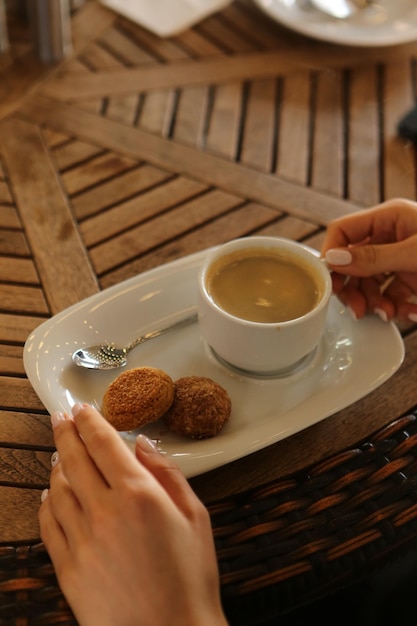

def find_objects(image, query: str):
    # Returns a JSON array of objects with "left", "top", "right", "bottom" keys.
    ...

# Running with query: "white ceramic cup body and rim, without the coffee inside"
[{"left": 198, "top": 236, "right": 332, "bottom": 376}]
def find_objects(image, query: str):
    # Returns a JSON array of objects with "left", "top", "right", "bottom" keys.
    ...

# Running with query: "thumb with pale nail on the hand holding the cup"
[{"left": 324, "top": 237, "right": 417, "bottom": 276}]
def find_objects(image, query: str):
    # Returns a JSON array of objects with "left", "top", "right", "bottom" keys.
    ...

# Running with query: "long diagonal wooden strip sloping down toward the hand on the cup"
[{"left": 22, "top": 97, "right": 358, "bottom": 224}]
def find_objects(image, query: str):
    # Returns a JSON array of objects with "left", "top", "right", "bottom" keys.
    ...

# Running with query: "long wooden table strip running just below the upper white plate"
[{"left": 41, "top": 44, "right": 417, "bottom": 101}]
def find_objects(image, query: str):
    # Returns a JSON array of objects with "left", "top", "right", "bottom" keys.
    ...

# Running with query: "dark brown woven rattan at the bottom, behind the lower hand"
[{"left": 0, "top": 412, "right": 417, "bottom": 626}]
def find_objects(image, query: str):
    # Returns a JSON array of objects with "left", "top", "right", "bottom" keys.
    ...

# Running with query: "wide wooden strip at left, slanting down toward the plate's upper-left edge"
[{"left": 0, "top": 119, "right": 98, "bottom": 313}]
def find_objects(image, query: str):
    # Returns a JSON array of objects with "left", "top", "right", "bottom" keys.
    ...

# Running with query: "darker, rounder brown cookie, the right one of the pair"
[{"left": 164, "top": 376, "right": 232, "bottom": 439}]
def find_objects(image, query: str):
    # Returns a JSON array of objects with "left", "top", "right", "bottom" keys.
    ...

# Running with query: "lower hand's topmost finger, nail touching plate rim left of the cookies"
[{"left": 73, "top": 405, "right": 147, "bottom": 488}]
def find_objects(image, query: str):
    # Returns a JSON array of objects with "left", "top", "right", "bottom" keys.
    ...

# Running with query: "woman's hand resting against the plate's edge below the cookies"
[{"left": 39, "top": 405, "right": 226, "bottom": 626}]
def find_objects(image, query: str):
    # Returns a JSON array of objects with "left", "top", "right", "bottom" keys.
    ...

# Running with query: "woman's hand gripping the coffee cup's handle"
[{"left": 321, "top": 200, "right": 417, "bottom": 322}]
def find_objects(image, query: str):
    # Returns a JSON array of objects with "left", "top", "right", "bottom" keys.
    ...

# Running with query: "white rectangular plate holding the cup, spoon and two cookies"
[{"left": 24, "top": 246, "right": 404, "bottom": 477}]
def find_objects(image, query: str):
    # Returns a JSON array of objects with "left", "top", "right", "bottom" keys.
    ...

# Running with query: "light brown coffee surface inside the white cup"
[{"left": 206, "top": 248, "right": 322, "bottom": 323}]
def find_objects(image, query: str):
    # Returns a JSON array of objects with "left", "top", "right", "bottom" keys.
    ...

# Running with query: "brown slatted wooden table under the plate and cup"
[{"left": 0, "top": 0, "right": 417, "bottom": 620}]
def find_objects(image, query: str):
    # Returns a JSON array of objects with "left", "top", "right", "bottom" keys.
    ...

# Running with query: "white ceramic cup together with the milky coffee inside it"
[{"left": 198, "top": 237, "right": 331, "bottom": 375}]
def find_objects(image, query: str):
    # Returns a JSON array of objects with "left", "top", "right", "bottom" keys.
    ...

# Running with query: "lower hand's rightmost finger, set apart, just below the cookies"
[{"left": 135, "top": 435, "right": 198, "bottom": 515}]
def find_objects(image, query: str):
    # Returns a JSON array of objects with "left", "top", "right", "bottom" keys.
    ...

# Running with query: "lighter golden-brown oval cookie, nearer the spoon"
[{"left": 101, "top": 367, "right": 174, "bottom": 431}]
